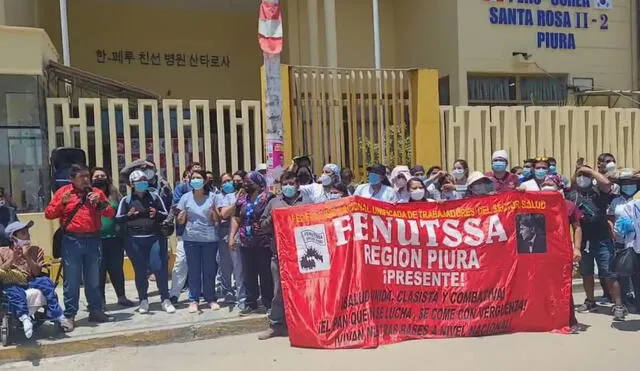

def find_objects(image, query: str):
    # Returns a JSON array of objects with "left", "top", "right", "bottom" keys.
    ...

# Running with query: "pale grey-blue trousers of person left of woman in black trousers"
[{"left": 218, "top": 229, "right": 247, "bottom": 307}]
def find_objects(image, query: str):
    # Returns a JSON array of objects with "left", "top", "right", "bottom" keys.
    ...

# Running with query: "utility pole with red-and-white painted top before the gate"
[{"left": 258, "top": 0, "right": 285, "bottom": 189}]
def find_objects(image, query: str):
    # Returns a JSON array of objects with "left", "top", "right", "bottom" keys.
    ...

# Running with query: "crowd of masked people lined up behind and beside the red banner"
[{"left": 0, "top": 150, "right": 640, "bottom": 339}]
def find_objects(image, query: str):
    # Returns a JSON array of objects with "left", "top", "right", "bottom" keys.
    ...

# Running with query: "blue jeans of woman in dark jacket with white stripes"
[{"left": 125, "top": 236, "right": 169, "bottom": 300}]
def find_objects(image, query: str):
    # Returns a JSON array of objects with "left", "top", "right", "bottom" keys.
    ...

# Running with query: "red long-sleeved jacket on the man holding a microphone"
[{"left": 44, "top": 184, "right": 116, "bottom": 234}]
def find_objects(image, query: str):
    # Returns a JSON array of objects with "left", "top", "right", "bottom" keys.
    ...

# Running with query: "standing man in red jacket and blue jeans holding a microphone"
[{"left": 44, "top": 165, "right": 115, "bottom": 330}]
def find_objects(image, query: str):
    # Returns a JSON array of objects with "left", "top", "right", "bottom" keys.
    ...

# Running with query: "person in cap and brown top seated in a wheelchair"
[{"left": 0, "top": 222, "right": 73, "bottom": 339}]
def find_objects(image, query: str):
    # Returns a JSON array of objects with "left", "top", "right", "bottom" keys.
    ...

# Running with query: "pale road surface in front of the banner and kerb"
[{"left": 0, "top": 294, "right": 640, "bottom": 371}]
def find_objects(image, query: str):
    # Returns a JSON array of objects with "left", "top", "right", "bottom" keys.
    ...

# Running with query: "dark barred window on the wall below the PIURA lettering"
[{"left": 467, "top": 74, "right": 567, "bottom": 106}]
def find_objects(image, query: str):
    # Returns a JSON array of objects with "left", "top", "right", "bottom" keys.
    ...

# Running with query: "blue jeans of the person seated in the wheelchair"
[{"left": 4, "top": 277, "right": 62, "bottom": 320}]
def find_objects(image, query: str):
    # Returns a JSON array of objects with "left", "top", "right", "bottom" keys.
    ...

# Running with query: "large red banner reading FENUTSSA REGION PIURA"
[{"left": 274, "top": 192, "right": 572, "bottom": 348}]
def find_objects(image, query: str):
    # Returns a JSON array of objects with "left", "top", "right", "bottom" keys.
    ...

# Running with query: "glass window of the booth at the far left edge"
[{"left": 0, "top": 75, "right": 51, "bottom": 213}]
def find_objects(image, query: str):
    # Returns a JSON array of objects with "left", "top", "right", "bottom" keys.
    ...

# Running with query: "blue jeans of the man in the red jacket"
[{"left": 62, "top": 234, "right": 102, "bottom": 318}]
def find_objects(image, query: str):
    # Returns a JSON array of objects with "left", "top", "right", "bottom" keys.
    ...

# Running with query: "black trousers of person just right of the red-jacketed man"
[{"left": 100, "top": 238, "right": 125, "bottom": 301}]
